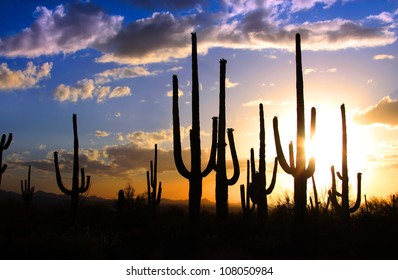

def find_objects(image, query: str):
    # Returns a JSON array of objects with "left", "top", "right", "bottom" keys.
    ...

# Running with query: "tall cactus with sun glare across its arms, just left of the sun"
[{"left": 273, "top": 34, "right": 316, "bottom": 220}]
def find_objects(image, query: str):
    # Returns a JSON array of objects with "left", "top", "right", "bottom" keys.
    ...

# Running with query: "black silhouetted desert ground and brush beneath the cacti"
[{"left": 0, "top": 191, "right": 398, "bottom": 260}]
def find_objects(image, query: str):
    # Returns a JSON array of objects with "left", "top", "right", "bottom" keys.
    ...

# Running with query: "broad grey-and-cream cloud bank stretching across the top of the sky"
[{"left": 0, "top": 0, "right": 397, "bottom": 65}]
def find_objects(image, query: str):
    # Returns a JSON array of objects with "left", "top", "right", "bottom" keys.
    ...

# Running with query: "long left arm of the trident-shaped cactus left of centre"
[{"left": 173, "top": 75, "right": 191, "bottom": 179}]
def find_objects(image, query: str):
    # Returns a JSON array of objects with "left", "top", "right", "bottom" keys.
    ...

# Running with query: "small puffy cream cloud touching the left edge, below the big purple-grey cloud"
[{"left": 0, "top": 61, "right": 53, "bottom": 90}]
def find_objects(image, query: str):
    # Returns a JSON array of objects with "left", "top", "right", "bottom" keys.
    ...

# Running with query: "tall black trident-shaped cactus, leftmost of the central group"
[{"left": 173, "top": 33, "right": 217, "bottom": 221}]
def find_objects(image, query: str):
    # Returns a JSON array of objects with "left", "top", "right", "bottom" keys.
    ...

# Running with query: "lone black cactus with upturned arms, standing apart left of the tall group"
[{"left": 54, "top": 114, "right": 90, "bottom": 224}]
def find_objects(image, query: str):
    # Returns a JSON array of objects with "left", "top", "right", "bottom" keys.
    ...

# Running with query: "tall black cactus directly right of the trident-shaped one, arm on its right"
[{"left": 214, "top": 59, "right": 240, "bottom": 220}]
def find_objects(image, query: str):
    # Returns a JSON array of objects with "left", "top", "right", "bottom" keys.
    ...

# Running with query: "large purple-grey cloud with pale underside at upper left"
[{"left": 0, "top": 3, "right": 123, "bottom": 57}]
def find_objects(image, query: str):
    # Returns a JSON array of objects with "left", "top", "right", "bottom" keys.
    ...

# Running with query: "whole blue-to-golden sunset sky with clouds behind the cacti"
[{"left": 0, "top": 0, "right": 398, "bottom": 206}]
